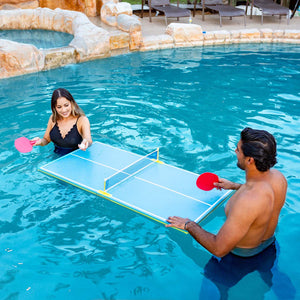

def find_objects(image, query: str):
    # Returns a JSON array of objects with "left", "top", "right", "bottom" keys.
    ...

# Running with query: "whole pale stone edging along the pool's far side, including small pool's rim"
[{"left": 0, "top": 7, "right": 300, "bottom": 79}]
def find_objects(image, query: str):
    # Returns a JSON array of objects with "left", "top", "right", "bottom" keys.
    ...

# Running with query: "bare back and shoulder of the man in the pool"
[{"left": 224, "top": 170, "right": 287, "bottom": 248}]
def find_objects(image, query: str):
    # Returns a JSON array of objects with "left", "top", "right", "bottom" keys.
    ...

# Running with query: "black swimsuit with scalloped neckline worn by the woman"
[{"left": 50, "top": 118, "right": 82, "bottom": 155}]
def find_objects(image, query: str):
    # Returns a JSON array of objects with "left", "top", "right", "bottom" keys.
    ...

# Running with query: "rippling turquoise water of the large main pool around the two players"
[{"left": 0, "top": 45, "right": 300, "bottom": 300}]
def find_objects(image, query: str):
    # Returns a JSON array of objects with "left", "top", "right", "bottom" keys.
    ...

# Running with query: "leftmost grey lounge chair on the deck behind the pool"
[{"left": 148, "top": 0, "right": 191, "bottom": 25}]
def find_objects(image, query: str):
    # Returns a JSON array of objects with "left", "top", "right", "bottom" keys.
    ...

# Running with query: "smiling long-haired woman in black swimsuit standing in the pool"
[{"left": 33, "top": 88, "right": 92, "bottom": 155}]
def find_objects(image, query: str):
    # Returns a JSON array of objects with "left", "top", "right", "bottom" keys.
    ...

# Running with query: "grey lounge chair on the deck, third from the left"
[{"left": 246, "top": 0, "right": 290, "bottom": 24}]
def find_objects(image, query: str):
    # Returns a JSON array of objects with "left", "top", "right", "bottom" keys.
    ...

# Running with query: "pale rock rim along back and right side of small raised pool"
[{"left": 0, "top": 8, "right": 110, "bottom": 62}]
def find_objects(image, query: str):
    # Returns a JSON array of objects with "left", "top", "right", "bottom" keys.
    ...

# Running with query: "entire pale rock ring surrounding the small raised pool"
[{"left": 0, "top": 8, "right": 111, "bottom": 78}]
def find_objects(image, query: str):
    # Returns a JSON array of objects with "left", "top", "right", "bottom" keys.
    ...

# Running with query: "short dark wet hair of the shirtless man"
[{"left": 241, "top": 127, "right": 277, "bottom": 172}]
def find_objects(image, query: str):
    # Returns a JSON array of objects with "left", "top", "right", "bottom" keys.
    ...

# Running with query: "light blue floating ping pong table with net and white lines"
[{"left": 39, "top": 142, "right": 232, "bottom": 232}]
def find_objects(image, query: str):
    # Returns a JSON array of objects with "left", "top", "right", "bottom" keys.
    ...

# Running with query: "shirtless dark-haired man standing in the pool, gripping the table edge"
[{"left": 166, "top": 128, "right": 287, "bottom": 257}]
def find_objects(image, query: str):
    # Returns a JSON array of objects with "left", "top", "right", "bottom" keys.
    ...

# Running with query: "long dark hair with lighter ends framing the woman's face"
[{"left": 51, "top": 88, "right": 85, "bottom": 123}]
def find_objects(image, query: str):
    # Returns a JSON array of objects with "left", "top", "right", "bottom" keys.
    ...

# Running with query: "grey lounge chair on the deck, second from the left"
[{"left": 194, "top": 0, "right": 246, "bottom": 27}]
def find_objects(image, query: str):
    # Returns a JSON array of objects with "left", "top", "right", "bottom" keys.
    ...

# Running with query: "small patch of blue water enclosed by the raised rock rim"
[{"left": 0, "top": 29, "right": 74, "bottom": 49}]
